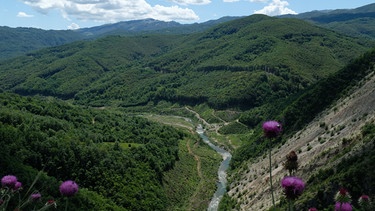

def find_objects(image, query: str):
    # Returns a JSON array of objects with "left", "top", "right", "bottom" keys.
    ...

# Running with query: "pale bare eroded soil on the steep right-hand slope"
[{"left": 228, "top": 73, "right": 375, "bottom": 211}]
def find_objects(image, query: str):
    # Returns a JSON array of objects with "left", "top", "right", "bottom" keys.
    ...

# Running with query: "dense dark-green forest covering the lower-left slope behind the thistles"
[{"left": 0, "top": 93, "right": 200, "bottom": 210}]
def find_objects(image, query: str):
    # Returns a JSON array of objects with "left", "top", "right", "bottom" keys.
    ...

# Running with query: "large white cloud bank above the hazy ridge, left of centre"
[{"left": 22, "top": 0, "right": 200, "bottom": 23}]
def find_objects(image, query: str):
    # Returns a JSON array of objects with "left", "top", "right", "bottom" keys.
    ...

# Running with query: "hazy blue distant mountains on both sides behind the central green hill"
[{"left": 0, "top": 4, "right": 375, "bottom": 61}]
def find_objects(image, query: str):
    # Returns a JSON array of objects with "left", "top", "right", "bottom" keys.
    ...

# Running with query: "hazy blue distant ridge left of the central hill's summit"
[{"left": 0, "top": 17, "right": 239, "bottom": 60}]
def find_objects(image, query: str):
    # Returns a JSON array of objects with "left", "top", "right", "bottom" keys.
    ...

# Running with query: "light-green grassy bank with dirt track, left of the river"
[{"left": 163, "top": 137, "right": 221, "bottom": 210}]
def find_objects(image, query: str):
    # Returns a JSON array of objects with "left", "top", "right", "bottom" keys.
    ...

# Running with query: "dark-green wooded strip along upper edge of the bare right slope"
[{"left": 232, "top": 46, "right": 375, "bottom": 168}]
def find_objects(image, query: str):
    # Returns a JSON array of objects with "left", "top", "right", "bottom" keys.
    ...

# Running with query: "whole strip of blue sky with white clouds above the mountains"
[{"left": 0, "top": 0, "right": 374, "bottom": 30}]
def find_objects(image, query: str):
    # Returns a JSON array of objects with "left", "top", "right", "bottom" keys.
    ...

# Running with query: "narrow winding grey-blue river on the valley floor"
[{"left": 196, "top": 125, "right": 232, "bottom": 211}]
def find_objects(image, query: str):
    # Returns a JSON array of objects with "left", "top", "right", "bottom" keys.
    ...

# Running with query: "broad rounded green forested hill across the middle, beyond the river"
[{"left": 0, "top": 15, "right": 373, "bottom": 108}]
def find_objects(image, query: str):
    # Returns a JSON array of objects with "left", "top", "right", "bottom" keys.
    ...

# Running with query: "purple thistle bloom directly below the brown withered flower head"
[{"left": 281, "top": 177, "right": 305, "bottom": 200}]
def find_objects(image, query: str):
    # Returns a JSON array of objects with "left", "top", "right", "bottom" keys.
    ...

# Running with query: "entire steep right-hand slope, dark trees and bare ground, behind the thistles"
[{"left": 220, "top": 49, "right": 375, "bottom": 211}]
